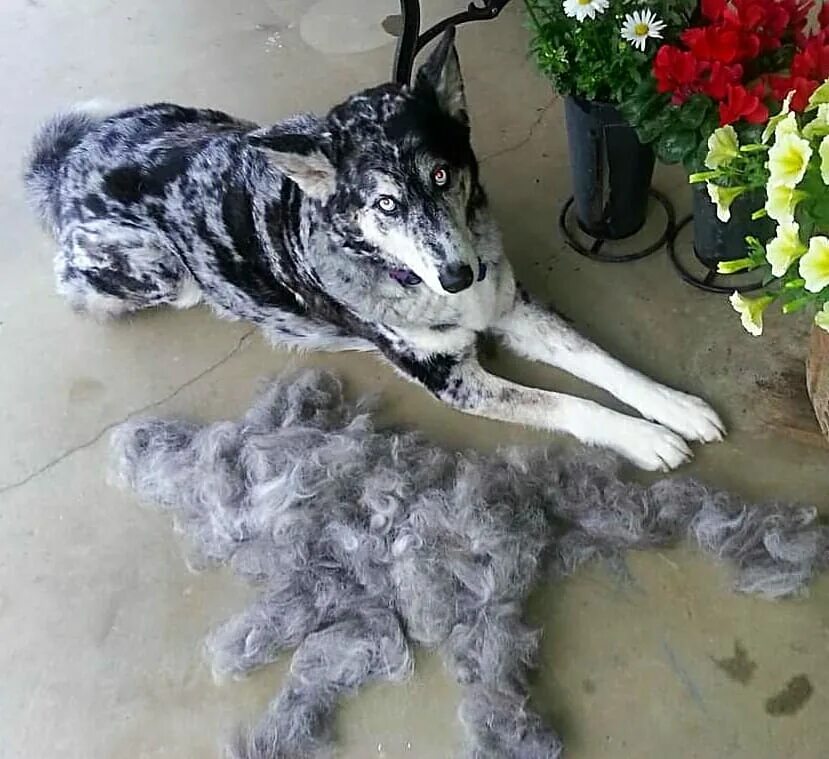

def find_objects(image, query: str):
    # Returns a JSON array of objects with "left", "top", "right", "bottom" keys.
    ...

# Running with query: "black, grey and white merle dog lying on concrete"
[{"left": 25, "top": 29, "right": 724, "bottom": 470}]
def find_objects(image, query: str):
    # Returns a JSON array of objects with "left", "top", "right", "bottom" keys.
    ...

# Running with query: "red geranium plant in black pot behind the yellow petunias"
[{"left": 624, "top": 0, "right": 816, "bottom": 269}]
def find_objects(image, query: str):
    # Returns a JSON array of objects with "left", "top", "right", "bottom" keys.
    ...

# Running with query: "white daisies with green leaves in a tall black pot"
[{"left": 525, "top": 0, "right": 696, "bottom": 240}]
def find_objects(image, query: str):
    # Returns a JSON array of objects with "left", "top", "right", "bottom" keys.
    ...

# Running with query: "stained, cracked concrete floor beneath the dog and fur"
[{"left": 0, "top": 0, "right": 829, "bottom": 759}]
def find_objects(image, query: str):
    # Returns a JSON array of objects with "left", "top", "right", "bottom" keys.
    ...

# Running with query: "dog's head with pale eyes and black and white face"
[{"left": 251, "top": 29, "right": 486, "bottom": 293}]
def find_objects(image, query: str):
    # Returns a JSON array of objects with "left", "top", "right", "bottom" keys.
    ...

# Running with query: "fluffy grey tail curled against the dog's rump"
[{"left": 23, "top": 100, "right": 121, "bottom": 232}]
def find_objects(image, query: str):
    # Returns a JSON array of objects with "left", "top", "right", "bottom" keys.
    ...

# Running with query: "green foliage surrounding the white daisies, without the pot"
[{"left": 525, "top": 0, "right": 696, "bottom": 105}]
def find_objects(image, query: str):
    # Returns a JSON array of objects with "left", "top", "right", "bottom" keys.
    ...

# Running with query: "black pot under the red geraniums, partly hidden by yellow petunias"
[{"left": 694, "top": 184, "right": 775, "bottom": 270}]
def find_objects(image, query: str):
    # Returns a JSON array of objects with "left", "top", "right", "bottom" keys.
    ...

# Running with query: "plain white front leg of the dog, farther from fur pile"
[{"left": 492, "top": 297, "right": 725, "bottom": 442}]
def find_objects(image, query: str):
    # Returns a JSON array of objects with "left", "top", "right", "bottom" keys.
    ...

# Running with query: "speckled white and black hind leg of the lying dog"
[{"left": 55, "top": 223, "right": 201, "bottom": 316}]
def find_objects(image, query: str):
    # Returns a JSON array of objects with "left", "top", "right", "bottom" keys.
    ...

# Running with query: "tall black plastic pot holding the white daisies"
[{"left": 564, "top": 97, "right": 654, "bottom": 240}]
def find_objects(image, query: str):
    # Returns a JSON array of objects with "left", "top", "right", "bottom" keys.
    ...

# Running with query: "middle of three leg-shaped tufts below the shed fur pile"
[{"left": 231, "top": 605, "right": 412, "bottom": 759}]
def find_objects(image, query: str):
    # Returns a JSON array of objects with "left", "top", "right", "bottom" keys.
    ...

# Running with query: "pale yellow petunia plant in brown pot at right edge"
[{"left": 704, "top": 73, "right": 829, "bottom": 435}]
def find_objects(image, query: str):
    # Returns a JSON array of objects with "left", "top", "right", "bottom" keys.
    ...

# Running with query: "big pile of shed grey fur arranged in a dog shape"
[{"left": 113, "top": 371, "right": 829, "bottom": 759}]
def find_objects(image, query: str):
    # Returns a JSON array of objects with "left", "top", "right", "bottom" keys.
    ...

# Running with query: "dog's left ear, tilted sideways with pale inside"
[{"left": 248, "top": 125, "right": 337, "bottom": 201}]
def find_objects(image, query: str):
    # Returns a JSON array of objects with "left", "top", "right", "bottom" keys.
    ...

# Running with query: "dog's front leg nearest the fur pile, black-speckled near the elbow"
[{"left": 414, "top": 357, "right": 691, "bottom": 471}]
